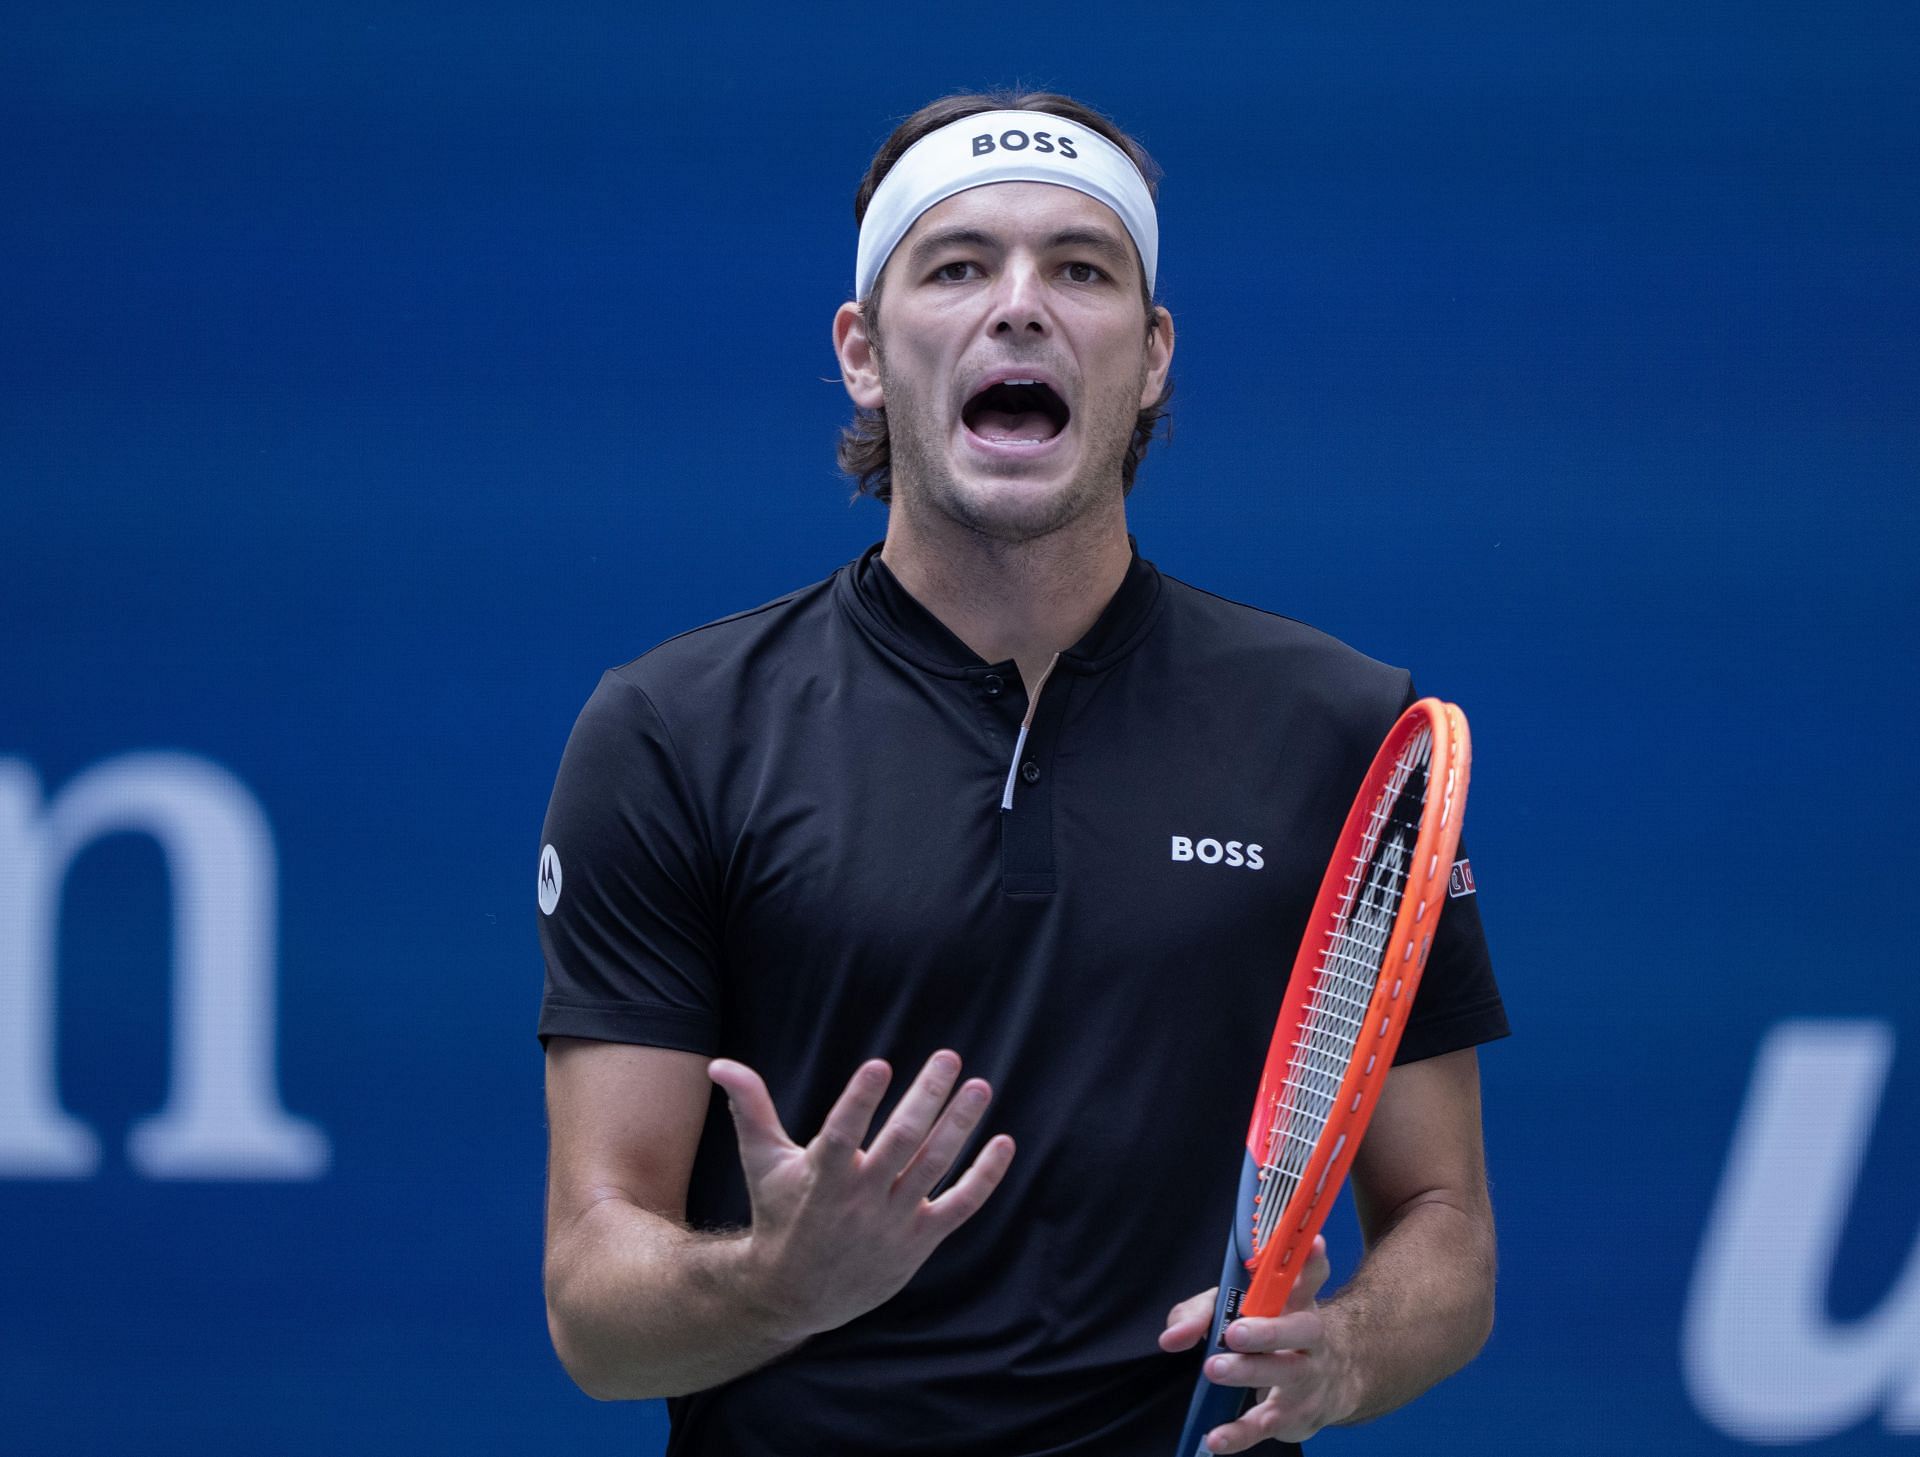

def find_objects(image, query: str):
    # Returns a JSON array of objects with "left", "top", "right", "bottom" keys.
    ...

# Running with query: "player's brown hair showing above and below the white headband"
[{"left": 839, "top": 90, "right": 1173, "bottom": 501}]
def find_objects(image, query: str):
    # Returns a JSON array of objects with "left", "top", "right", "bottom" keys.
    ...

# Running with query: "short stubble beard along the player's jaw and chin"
[{"left": 877, "top": 359, "right": 1146, "bottom": 545}]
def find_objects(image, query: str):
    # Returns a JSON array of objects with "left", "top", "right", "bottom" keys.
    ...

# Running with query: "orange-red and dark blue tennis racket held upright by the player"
[{"left": 1177, "top": 699, "right": 1473, "bottom": 1457}]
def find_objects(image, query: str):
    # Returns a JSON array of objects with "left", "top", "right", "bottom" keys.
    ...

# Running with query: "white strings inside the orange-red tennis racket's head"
[{"left": 1254, "top": 728, "right": 1432, "bottom": 1250}]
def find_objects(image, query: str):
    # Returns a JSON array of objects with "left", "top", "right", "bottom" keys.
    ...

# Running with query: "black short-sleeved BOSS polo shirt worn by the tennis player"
[{"left": 540, "top": 549, "right": 1507, "bottom": 1457}]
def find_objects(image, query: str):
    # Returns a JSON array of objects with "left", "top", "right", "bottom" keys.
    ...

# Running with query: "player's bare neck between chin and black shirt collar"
[{"left": 879, "top": 501, "right": 1133, "bottom": 691}]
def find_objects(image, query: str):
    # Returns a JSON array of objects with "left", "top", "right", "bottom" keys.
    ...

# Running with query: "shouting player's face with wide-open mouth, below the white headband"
[{"left": 849, "top": 182, "right": 1173, "bottom": 541}]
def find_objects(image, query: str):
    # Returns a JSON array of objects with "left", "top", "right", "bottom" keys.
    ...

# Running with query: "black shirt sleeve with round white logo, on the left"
[{"left": 538, "top": 672, "right": 720, "bottom": 1054}]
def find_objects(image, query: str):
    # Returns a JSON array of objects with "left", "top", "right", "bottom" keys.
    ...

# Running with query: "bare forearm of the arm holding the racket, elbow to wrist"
[{"left": 1321, "top": 1200, "right": 1494, "bottom": 1424}]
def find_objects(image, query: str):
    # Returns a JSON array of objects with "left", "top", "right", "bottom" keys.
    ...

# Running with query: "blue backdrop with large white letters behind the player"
[{"left": 0, "top": 0, "right": 1920, "bottom": 1453}]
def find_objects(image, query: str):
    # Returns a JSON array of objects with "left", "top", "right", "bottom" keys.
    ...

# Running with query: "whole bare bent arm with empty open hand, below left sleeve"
[{"left": 545, "top": 1037, "right": 1014, "bottom": 1399}]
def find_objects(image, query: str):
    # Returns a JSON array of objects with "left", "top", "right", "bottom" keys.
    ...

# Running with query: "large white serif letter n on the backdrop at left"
[{"left": 0, "top": 752, "right": 328, "bottom": 1179}]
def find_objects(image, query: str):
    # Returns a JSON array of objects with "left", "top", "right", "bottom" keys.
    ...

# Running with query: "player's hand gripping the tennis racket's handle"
[{"left": 1160, "top": 1238, "right": 1356, "bottom": 1451}]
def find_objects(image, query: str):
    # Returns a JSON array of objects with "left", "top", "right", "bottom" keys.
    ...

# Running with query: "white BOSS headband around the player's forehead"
[{"left": 852, "top": 111, "right": 1160, "bottom": 299}]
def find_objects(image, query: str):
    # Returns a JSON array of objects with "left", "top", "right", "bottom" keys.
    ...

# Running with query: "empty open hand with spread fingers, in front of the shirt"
[{"left": 707, "top": 1052, "right": 1014, "bottom": 1336}]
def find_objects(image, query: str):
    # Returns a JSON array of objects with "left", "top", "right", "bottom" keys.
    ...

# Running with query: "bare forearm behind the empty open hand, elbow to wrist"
[{"left": 547, "top": 1198, "right": 804, "bottom": 1401}]
